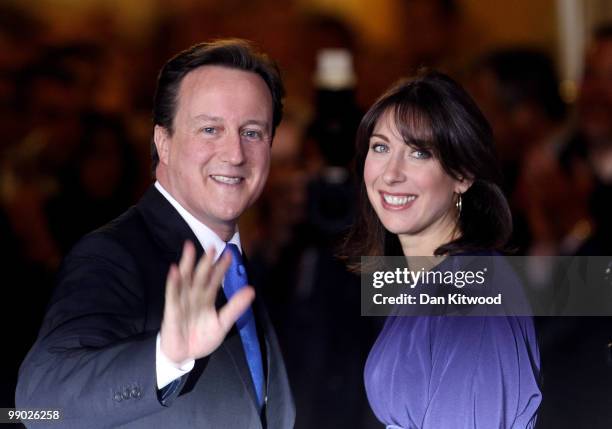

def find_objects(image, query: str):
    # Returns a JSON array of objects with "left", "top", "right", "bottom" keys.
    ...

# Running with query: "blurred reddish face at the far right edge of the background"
[{"left": 578, "top": 38, "right": 612, "bottom": 144}]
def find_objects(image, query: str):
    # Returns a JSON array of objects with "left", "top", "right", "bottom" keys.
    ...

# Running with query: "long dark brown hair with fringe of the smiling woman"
[{"left": 344, "top": 70, "right": 512, "bottom": 268}]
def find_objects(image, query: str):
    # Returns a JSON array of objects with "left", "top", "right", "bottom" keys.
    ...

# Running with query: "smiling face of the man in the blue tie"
[{"left": 155, "top": 66, "right": 272, "bottom": 240}]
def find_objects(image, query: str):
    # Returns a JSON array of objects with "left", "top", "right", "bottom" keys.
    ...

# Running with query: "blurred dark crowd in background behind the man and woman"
[{"left": 0, "top": 0, "right": 612, "bottom": 428}]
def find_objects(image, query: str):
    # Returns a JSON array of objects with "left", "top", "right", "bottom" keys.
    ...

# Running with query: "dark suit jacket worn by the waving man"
[{"left": 16, "top": 187, "right": 295, "bottom": 429}]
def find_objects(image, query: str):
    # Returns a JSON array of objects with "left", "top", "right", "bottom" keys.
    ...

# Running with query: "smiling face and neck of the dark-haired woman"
[{"left": 364, "top": 110, "right": 468, "bottom": 252}]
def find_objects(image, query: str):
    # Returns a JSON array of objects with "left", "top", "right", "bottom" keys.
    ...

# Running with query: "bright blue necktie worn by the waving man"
[{"left": 223, "top": 243, "right": 264, "bottom": 410}]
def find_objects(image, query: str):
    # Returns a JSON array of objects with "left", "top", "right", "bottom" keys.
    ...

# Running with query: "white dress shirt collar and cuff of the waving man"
[{"left": 155, "top": 181, "right": 242, "bottom": 389}]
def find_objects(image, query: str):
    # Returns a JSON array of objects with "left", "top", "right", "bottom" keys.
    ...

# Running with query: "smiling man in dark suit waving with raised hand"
[{"left": 16, "top": 40, "right": 295, "bottom": 429}]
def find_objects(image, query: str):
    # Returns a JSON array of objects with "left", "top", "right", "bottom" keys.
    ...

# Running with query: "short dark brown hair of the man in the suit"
[{"left": 151, "top": 39, "right": 285, "bottom": 174}]
